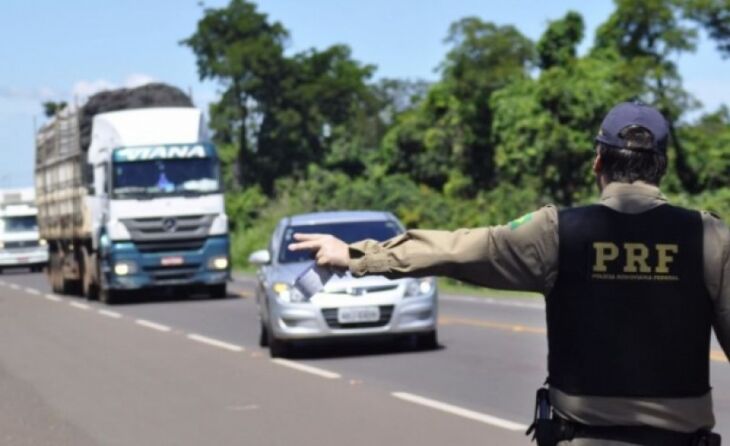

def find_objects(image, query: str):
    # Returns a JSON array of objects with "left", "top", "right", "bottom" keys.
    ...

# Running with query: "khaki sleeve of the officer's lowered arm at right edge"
[{"left": 702, "top": 212, "right": 730, "bottom": 357}]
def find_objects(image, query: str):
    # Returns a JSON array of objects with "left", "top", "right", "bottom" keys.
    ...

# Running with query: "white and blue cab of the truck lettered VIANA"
[{"left": 86, "top": 108, "right": 230, "bottom": 301}]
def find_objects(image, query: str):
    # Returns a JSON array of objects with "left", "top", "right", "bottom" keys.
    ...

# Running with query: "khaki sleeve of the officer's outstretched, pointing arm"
[{"left": 349, "top": 206, "right": 558, "bottom": 293}]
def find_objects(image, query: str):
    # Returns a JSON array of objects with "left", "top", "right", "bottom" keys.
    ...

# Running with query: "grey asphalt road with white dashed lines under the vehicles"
[{"left": 0, "top": 273, "right": 730, "bottom": 446}]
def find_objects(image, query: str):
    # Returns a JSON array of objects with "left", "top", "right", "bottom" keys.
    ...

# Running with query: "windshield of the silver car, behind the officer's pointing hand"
[{"left": 279, "top": 221, "right": 403, "bottom": 263}]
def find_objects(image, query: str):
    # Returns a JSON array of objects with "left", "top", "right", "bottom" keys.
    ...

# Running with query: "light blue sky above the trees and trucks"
[{"left": 0, "top": 0, "right": 730, "bottom": 187}]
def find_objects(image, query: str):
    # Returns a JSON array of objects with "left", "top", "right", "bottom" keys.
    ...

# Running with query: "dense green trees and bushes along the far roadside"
[{"left": 182, "top": 0, "right": 730, "bottom": 264}]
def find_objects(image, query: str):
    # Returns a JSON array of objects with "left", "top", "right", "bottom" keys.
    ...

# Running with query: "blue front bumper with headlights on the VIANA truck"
[{"left": 104, "top": 236, "right": 230, "bottom": 290}]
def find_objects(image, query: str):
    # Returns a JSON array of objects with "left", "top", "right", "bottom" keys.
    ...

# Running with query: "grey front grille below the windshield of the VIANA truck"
[{"left": 121, "top": 214, "right": 215, "bottom": 242}]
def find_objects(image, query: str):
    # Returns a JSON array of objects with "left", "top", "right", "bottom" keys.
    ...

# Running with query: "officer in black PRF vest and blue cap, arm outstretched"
[{"left": 290, "top": 103, "right": 730, "bottom": 446}]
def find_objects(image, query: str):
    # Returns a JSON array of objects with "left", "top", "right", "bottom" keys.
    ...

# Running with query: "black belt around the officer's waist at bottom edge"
[{"left": 555, "top": 420, "right": 720, "bottom": 446}]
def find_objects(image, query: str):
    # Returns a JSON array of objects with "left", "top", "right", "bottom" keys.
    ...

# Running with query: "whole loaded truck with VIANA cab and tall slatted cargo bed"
[{"left": 36, "top": 85, "right": 230, "bottom": 303}]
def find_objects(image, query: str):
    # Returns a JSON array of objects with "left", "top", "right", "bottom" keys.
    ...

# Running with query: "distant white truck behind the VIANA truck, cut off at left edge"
[{"left": 0, "top": 188, "right": 48, "bottom": 272}]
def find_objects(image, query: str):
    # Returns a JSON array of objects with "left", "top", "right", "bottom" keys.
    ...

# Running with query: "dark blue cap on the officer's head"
[{"left": 596, "top": 102, "right": 669, "bottom": 154}]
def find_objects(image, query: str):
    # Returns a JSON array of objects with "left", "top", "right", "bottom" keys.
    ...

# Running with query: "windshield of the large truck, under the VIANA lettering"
[{"left": 112, "top": 158, "right": 220, "bottom": 198}]
